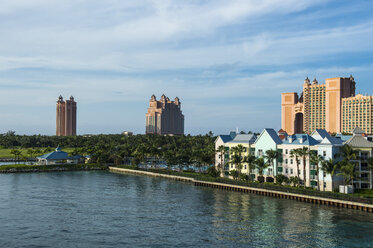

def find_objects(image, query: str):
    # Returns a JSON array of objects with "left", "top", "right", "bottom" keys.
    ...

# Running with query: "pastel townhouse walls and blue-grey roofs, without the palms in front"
[{"left": 215, "top": 128, "right": 373, "bottom": 191}]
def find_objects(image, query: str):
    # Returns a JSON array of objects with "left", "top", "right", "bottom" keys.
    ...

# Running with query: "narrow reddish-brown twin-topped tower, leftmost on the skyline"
[{"left": 56, "top": 96, "right": 76, "bottom": 136}]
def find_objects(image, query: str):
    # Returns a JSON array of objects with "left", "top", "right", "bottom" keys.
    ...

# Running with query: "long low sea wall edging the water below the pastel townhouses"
[{"left": 109, "top": 167, "right": 373, "bottom": 213}]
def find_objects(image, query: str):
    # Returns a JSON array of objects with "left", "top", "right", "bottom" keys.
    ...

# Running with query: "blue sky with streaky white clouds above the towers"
[{"left": 0, "top": 0, "right": 373, "bottom": 135}]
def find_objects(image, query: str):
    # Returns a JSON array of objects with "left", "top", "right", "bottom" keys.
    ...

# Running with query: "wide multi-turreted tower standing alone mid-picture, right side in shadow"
[{"left": 146, "top": 95, "right": 184, "bottom": 135}]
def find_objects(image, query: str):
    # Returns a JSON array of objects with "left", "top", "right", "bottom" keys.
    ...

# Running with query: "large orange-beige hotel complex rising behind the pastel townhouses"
[{"left": 281, "top": 76, "right": 373, "bottom": 134}]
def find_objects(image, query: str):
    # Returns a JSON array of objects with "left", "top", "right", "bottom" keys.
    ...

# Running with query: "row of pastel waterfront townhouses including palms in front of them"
[{"left": 215, "top": 127, "right": 373, "bottom": 191}]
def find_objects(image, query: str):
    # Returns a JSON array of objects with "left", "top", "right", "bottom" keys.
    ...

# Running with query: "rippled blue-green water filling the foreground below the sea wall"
[{"left": 0, "top": 171, "right": 373, "bottom": 247}]
